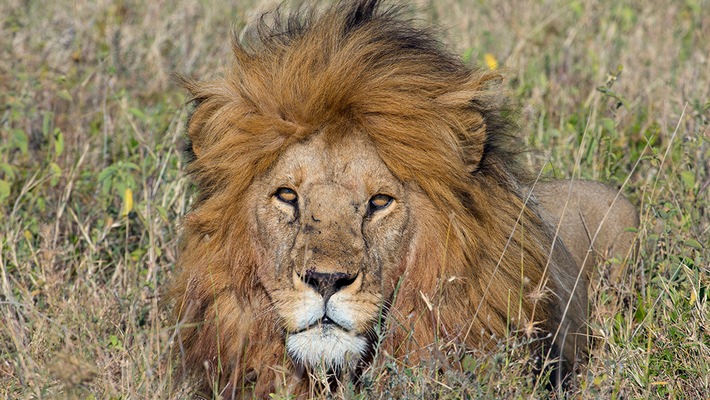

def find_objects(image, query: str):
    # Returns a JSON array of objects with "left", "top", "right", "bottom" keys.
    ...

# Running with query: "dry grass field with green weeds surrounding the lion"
[{"left": 0, "top": 0, "right": 710, "bottom": 399}]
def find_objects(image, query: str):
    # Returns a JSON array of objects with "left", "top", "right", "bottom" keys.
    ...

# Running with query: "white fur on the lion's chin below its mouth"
[{"left": 286, "top": 325, "right": 367, "bottom": 368}]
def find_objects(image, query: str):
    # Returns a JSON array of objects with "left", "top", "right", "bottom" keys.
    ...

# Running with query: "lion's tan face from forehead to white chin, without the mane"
[{"left": 250, "top": 130, "right": 416, "bottom": 368}]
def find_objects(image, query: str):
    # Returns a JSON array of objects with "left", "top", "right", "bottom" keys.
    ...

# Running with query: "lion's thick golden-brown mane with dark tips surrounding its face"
[{"left": 169, "top": 0, "right": 586, "bottom": 396}]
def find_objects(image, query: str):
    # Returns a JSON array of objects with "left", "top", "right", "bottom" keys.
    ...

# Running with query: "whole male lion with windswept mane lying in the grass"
[{"left": 171, "top": 0, "right": 636, "bottom": 397}]
